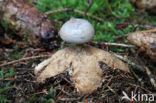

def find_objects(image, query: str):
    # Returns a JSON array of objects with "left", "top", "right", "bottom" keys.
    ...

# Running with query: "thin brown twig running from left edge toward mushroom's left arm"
[{"left": 0, "top": 55, "right": 51, "bottom": 67}]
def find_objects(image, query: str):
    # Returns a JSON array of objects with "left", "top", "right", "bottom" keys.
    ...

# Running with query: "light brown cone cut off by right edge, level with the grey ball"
[{"left": 127, "top": 29, "right": 156, "bottom": 61}]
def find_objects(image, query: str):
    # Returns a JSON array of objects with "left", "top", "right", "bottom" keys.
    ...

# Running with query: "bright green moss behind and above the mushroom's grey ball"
[{"left": 36, "top": 0, "right": 135, "bottom": 45}]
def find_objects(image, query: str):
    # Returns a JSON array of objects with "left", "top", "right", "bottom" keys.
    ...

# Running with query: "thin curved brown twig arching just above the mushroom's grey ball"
[{"left": 45, "top": 8, "right": 104, "bottom": 22}]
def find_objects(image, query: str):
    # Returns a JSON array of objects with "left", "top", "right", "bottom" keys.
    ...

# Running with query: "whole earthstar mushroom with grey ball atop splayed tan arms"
[{"left": 35, "top": 18, "right": 129, "bottom": 94}]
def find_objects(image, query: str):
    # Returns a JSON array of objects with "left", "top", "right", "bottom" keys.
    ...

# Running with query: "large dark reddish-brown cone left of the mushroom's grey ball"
[{"left": 0, "top": 0, "right": 56, "bottom": 46}]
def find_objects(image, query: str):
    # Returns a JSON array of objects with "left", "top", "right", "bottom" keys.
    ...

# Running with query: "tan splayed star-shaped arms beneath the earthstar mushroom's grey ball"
[{"left": 35, "top": 45, "right": 129, "bottom": 94}]
